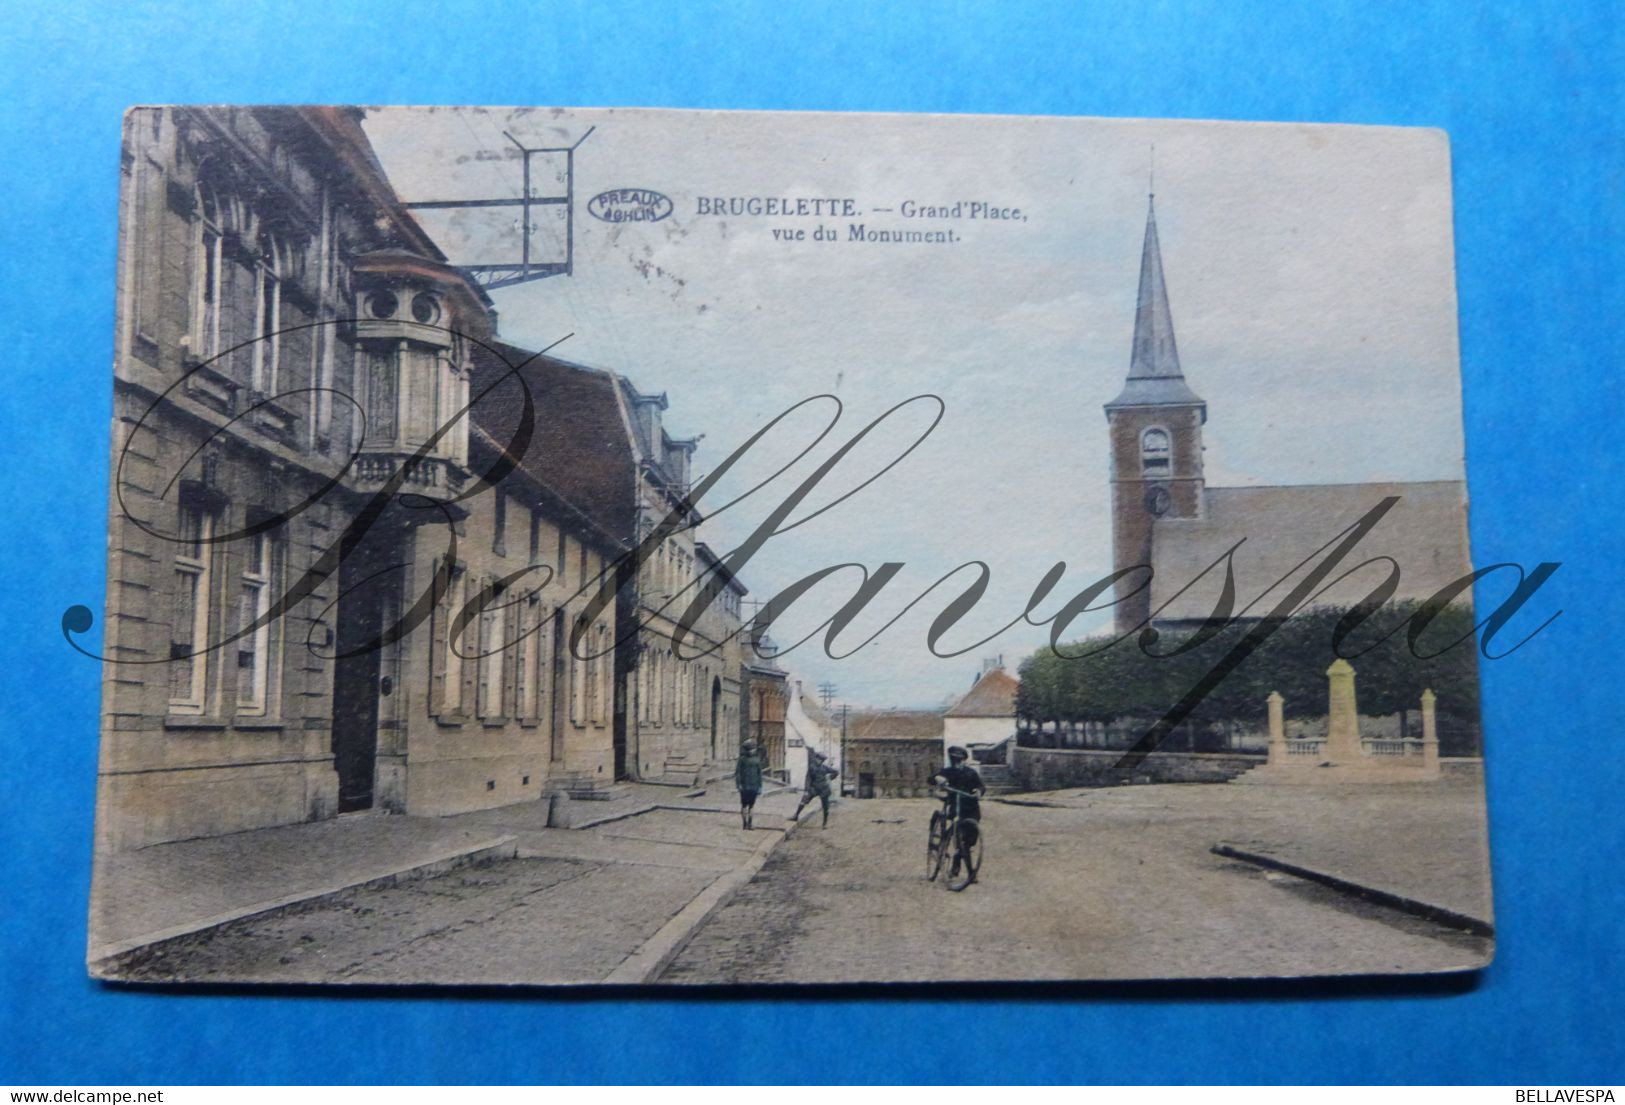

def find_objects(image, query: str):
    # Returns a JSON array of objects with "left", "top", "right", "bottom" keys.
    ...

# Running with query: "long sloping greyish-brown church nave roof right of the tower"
[{"left": 1151, "top": 479, "right": 1472, "bottom": 622}]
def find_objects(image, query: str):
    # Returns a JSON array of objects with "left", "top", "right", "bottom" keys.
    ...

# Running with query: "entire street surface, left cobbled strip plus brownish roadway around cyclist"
[{"left": 108, "top": 785, "right": 1492, "bottom": 985}]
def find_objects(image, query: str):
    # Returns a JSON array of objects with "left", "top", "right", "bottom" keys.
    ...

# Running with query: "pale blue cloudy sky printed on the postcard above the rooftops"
[{"left": 364, "top": 107, "right": 1464, "bottom": 707}]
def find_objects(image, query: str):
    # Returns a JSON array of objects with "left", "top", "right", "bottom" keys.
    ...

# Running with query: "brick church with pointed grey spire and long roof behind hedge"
[{"left": 1105, "top": 197, "right": 1472, "bottom": 635}]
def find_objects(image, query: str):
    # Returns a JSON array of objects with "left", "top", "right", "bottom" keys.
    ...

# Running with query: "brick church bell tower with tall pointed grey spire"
[{"left": 1105, "top": 193, "right": 1207, "bottom": 634}]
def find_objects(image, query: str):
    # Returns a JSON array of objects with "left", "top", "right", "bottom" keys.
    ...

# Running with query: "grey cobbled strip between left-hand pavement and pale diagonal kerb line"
[{"left": 115, "top": 790, "right": 795, "bottom": 985}]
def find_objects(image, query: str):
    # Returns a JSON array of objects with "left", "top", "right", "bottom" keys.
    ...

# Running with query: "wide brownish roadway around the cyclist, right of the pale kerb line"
[{"left": 661, "top": 776, "right": 1490, "bottom": 983}]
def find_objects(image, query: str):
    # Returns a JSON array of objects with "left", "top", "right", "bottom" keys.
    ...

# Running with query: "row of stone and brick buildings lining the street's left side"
[{"left": 98, "top": 107, "right": 757, "bottom": 848}]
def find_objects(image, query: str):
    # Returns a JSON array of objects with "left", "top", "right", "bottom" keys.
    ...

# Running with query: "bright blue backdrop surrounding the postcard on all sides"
[{"left": 0, "top": 0, "right": 1625, "bottom": 1086}]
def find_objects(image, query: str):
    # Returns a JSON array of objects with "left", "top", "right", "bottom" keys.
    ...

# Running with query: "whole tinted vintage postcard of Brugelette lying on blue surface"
[{"left": 85, "top": 107, "right": 1500, "bottom": 985}]
